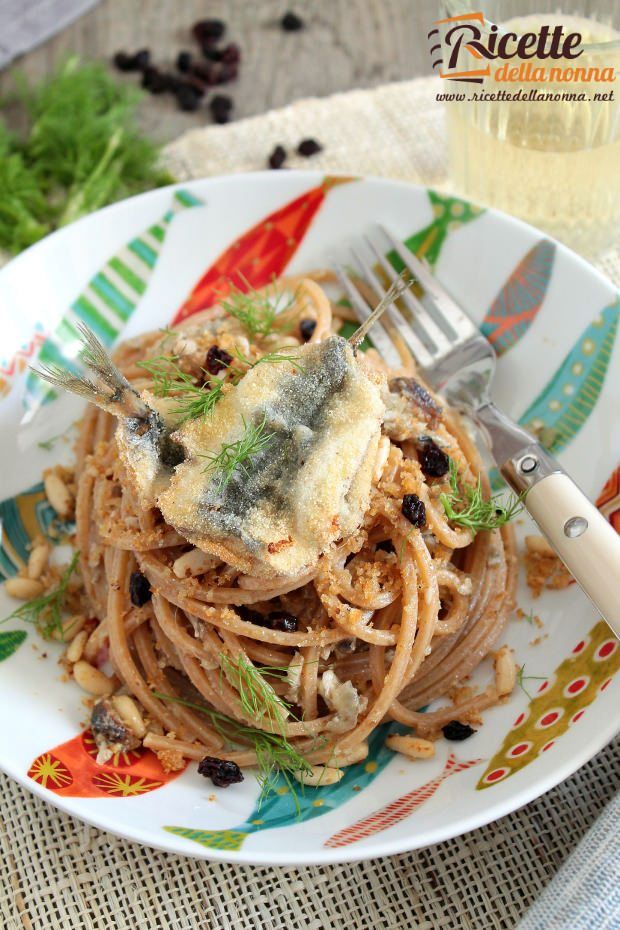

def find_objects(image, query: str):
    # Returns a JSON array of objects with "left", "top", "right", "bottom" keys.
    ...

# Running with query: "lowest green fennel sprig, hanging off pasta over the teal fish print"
[{"left": 153, "top": 691, "right": 312, "bottom": 812}]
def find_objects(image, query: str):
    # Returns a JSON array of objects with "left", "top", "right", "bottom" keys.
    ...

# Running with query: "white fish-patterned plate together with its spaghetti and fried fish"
[{"left": 0, "top": 171, "right": 620, "bottom": 865}]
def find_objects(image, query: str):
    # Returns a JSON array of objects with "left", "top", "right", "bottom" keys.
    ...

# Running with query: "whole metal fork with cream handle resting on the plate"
[{"left": 335, "top": 226, "right": 620, "bottom": 638}]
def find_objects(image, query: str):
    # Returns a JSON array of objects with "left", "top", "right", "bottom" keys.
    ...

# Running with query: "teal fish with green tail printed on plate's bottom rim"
[{"left": 164, "top": 723, "right": 405, "bottom": 851}]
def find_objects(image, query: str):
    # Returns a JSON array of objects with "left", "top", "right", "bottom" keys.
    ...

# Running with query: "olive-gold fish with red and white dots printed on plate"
[{"left": 476, "top": 620, "right": 620, "bottom": 789}]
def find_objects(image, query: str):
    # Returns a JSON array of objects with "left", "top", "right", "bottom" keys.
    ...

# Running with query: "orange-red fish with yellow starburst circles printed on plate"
[{"left": 27, "top": 730, "right": 182, "bottom": 798}]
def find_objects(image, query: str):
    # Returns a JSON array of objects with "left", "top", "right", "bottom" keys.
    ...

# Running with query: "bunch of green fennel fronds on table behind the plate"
[{"left": 0, "top": 58, "right": 174, "bottom": 254}]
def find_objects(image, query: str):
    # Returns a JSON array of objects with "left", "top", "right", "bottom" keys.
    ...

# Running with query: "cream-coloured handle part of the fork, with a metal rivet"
[{"left": 525, "top": 473, "right": 620, "bottom": 638}]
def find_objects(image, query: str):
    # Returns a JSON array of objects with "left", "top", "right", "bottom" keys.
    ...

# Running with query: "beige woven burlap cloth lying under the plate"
[{"left": 0, "top": 79, "right": 620, "bottom": 930}]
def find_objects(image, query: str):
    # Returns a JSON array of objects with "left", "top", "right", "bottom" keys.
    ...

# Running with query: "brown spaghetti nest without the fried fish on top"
[{"left": 38, "top": 275, "right": 516, "bottom": 783}]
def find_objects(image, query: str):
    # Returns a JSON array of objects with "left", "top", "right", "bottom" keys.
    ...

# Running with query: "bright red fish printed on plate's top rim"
[{"left": 173, "top": 177, "right": 356, "bottom": 323}]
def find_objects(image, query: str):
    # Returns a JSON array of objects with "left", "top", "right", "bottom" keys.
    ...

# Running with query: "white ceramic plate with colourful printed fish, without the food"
[{"left": 0, "top": 171, "right": 620, "bottom": 864}]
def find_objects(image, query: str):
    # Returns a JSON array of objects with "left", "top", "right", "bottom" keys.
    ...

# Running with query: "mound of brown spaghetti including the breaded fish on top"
[{"left": 31, "top": 274, "right": 516, "bottom": 784}]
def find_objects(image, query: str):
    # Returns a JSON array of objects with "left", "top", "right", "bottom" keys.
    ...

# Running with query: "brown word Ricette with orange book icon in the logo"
[{"left": 428, "top": 12, "right": 583, "bottom": 84}]
